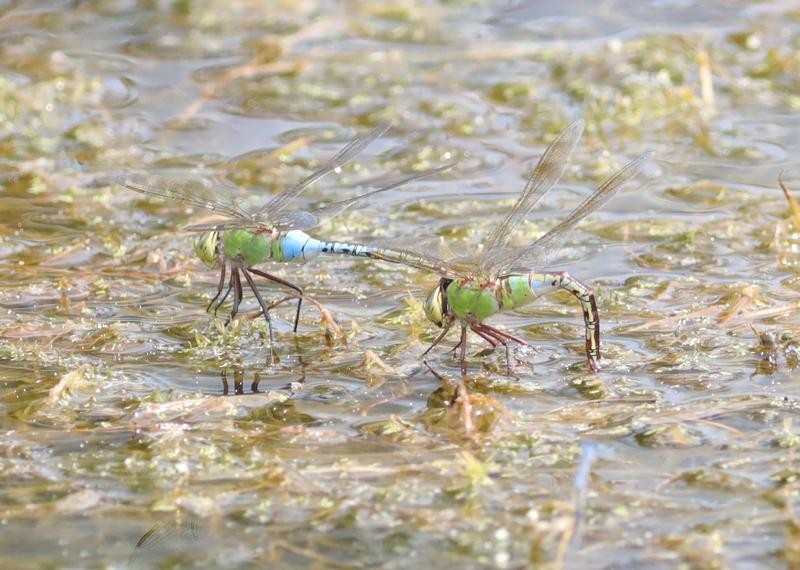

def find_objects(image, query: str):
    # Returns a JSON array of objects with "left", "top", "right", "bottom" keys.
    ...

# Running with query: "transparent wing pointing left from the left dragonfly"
[{"left": 118, "top": 174, "right": 249, "bottom": 220}]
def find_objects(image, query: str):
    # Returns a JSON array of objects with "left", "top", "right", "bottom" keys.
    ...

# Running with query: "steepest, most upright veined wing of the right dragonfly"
[{"left": 481, "top": 119, "right": 585, "bottom": 265}]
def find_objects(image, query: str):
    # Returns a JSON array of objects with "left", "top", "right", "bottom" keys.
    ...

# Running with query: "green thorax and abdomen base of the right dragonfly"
[{"left": 447, "top": 275, "right": 537, "bottom": 321}]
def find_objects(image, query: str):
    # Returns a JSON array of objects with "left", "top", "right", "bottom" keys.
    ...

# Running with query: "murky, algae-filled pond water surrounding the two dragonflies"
[{"left": 0, "top": 0, "right": 800, "bottom": 568}]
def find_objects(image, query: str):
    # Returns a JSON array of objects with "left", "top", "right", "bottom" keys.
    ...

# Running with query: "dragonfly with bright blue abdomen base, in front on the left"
[{"left": 120, "top": 124, "right": 452, "bottom": 351}]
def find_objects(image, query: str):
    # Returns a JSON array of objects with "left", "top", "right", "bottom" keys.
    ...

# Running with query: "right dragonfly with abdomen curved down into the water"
[{"left": 354, "top": 119, "right": 652, "bottom": 373}]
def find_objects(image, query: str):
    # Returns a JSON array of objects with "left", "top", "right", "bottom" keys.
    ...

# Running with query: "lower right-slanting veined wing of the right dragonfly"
[{"left": 492, "top": 152, "right": 653, "bottom": 274}]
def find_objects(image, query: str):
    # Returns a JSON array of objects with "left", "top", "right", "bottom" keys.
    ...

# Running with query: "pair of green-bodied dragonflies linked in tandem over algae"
[{"left": 122, "top": 120, "right": 650, "bottom": 371}]
